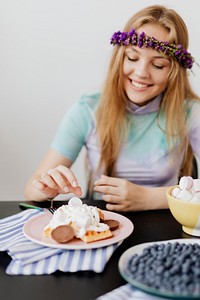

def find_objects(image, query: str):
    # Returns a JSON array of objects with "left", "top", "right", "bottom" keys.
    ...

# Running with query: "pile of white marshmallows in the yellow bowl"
[{"left": 172, "top": 176, "right": 200, "bottom": 203}]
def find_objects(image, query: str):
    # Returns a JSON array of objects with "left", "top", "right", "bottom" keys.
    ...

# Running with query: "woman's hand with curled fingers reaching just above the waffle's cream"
[{"left": 32, "top": 165, "right": 82, "bottom": 199}]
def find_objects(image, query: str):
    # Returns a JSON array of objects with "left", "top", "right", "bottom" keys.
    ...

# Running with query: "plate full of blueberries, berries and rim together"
[{"left": 118, "top": 238, "right": 200, "bottom": 300}]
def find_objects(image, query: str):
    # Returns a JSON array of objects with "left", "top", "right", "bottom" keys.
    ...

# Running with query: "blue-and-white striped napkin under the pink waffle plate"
[{"left": 0, "top": 209, "right": 122, "bottom": 275}]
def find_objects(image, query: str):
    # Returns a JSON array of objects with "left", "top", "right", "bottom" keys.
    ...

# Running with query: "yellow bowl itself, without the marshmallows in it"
[{"left": 167, "top": 186, "right": 200, "bottom": 236}]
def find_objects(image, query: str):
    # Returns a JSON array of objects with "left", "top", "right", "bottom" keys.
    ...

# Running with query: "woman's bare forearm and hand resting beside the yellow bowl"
[{"left": 94, "top": 175, "right": 168, "bottom": 211}]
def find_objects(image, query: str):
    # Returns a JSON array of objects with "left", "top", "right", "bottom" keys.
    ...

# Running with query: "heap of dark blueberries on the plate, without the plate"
[{"left": 127, "top": 242, "right": 200, "bottom": 296}]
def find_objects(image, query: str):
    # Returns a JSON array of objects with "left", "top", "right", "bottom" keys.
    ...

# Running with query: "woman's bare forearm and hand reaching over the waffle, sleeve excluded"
[{"left": 25, "top": 149, "right": 82, "bottom": 201}]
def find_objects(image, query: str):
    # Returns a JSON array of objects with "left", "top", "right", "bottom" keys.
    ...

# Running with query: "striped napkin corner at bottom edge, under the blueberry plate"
[{"left": 96, "top": 283, "right": 173, "bottom": 300}]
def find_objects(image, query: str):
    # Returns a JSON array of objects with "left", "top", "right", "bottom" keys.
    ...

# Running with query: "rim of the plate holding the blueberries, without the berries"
[{"left": 118, "top": 238, "right": 200, "bottom": 300}]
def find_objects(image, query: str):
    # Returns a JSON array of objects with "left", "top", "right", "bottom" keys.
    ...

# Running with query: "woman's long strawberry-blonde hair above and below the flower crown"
[{"left": 93, "top": 5, "right": 199, "bottom": 185}]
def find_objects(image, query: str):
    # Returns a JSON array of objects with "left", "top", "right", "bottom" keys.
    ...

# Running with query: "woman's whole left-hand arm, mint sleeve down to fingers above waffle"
[{"left": 25, "top": 96, "right": 98, "bottom": 201}]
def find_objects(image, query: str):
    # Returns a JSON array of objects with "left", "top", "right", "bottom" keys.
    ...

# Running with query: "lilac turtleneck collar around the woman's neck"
[{"left": 127, "top": 93, "right": 163, "bottom": 115}]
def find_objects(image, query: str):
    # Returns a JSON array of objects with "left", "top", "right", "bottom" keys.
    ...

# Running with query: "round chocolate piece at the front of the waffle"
[{"left": 51, "top": 225, "right": 74, "bottom": 243}]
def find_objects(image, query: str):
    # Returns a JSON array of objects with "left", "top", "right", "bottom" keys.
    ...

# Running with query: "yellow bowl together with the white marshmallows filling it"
[{"left": 167, "top": 176, "right": 200, "bottom": 237}]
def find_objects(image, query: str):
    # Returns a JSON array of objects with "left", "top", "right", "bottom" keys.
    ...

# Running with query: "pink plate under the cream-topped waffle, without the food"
[{"left": 23, "top": 210, "right": 134, "bottom": 250}]
